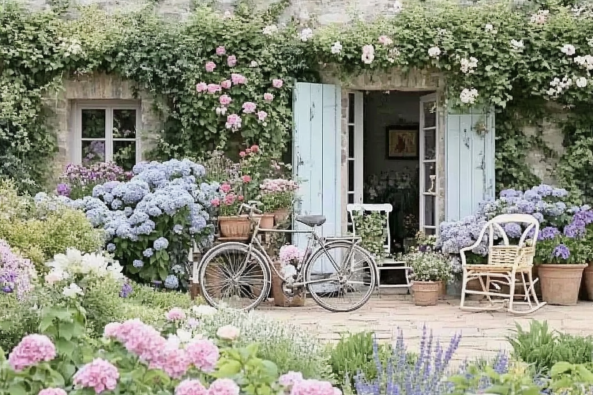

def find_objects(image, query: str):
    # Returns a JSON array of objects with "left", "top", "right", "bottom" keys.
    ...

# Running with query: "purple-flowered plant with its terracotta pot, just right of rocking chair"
[{"left": 535, "top": 229, "right": 591, "bottom": 306}]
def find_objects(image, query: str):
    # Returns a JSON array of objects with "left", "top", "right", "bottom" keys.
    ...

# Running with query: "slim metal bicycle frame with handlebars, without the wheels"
[{"left": 239, "top": 204, "right": 361, "bottom": 287}]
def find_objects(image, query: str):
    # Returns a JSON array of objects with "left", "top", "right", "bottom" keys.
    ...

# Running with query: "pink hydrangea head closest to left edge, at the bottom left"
[{"left": 8, "top": 334, "right": 56, "bottom": 372}]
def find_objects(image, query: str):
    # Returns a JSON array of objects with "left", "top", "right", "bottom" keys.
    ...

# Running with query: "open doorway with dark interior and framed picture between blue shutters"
[{"left": 348, "top": 91, "right": 438, "bottom": 260}]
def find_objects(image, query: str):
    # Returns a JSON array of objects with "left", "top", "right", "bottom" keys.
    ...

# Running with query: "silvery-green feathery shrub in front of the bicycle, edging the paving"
[{"left": 201, "top": 309, "right": 333, "bottom": 380}]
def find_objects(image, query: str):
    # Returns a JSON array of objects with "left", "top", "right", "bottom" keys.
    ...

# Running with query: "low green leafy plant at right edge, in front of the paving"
[{"left": 508, "top": 321, "right": 593, "bottom": 372}]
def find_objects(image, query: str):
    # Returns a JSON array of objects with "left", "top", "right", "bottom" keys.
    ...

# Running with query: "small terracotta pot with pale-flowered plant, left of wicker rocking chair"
[{"left": 403, "top": 250, "right": 451, "bottom": 306}]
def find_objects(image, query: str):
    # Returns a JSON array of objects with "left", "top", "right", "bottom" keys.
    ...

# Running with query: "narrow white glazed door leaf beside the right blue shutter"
[{"left": 418, "top": 93, "right": 440, "bottom": 235}]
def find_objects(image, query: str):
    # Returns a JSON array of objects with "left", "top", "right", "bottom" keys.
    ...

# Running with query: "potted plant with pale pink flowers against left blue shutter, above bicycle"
[{"left": 259, "top": 178, "right": 298, "bottom": 224}]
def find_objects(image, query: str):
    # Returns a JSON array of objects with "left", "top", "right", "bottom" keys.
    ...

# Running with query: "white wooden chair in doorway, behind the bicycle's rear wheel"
[{"left": 346, "top": 203, "right": 412, "bottom": 296}]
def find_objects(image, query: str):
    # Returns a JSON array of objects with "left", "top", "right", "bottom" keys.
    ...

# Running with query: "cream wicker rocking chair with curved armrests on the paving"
[{"left": 459, "top": 214, "right": 545, "bottom": 314}]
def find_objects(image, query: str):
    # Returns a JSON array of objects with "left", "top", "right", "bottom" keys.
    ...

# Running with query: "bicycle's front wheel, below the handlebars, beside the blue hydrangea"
[{"left": 199, "top": 243, "right": 271, "bottom": 310}]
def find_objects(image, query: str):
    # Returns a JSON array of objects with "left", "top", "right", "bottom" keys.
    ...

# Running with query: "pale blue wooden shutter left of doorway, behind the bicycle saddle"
[{"left": 292, "top": 82, "right": 342, "bottom": 249}]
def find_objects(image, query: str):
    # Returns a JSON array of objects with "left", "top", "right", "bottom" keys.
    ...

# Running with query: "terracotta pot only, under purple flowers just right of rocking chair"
[{"left": 538, "top": 265, "right": 587, "bottom": 306}]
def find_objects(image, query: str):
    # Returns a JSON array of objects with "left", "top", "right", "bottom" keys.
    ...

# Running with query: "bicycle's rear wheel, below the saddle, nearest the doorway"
[{"left": 305, "top": 242, "right": 377, "bottom": 312}]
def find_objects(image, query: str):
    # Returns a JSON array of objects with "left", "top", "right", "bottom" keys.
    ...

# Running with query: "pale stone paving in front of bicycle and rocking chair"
[{"left": 258, "top": 295, "right": 593, "bottom": 360}]
